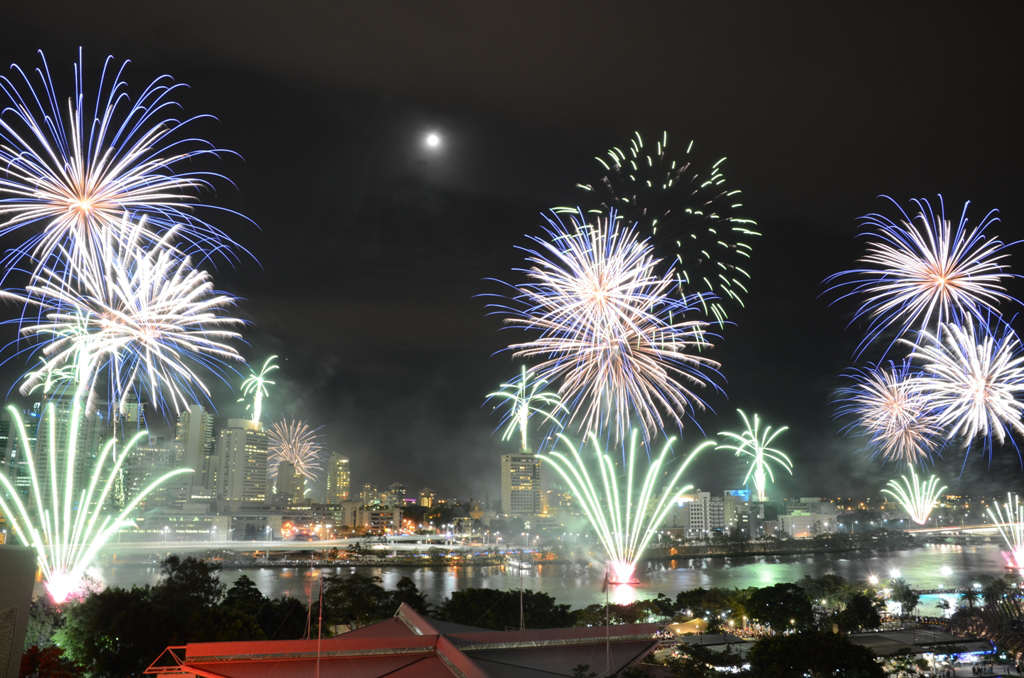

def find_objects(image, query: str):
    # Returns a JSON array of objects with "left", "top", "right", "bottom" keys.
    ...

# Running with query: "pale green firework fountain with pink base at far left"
[{"left": 0, "top": 398, "right": 193, "bottom": 603}]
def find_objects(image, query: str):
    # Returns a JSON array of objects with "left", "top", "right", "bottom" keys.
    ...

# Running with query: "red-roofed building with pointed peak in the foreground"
[{"left": 145, "top": 604, "right": 660, "bottom": 678}]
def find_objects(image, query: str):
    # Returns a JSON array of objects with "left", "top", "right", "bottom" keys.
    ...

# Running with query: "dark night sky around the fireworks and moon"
[{"left": 2, "top": 2, "right": 1024, "bottom": 498}]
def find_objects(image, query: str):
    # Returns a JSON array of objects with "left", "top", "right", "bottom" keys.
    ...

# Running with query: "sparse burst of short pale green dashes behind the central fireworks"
[{"left": 560, "top": 132, "right": 761, "bottom": 325}]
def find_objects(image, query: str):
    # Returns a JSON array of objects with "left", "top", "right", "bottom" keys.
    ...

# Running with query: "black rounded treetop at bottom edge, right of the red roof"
[{"left": 746, "top": 631, "right": 885, "bottom": 678}]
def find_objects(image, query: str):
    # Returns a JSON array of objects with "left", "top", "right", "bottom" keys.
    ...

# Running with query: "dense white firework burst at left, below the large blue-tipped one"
[{"left": 0, "top": 217, "right": 243, "bottom": 413}]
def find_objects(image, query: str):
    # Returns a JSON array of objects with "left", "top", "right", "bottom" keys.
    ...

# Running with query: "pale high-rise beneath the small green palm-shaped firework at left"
[{"left": 211, "top": 419, "right": 268, "bottom": 504}]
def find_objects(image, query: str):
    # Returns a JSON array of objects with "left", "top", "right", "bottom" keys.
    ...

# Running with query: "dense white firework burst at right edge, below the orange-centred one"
[{"left": 903, "top": 317, "right": 1024, "bottom": 455}]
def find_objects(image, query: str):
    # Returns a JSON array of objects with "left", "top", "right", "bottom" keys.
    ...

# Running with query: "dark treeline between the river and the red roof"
[{"left": 23, "top": 556, "right": 905, "bottom": 676}]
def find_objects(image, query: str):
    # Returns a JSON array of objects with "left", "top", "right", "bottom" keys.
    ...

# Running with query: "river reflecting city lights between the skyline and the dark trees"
[{"left": 96, "top": 545, "right": 1004, "bottom": 607}]
